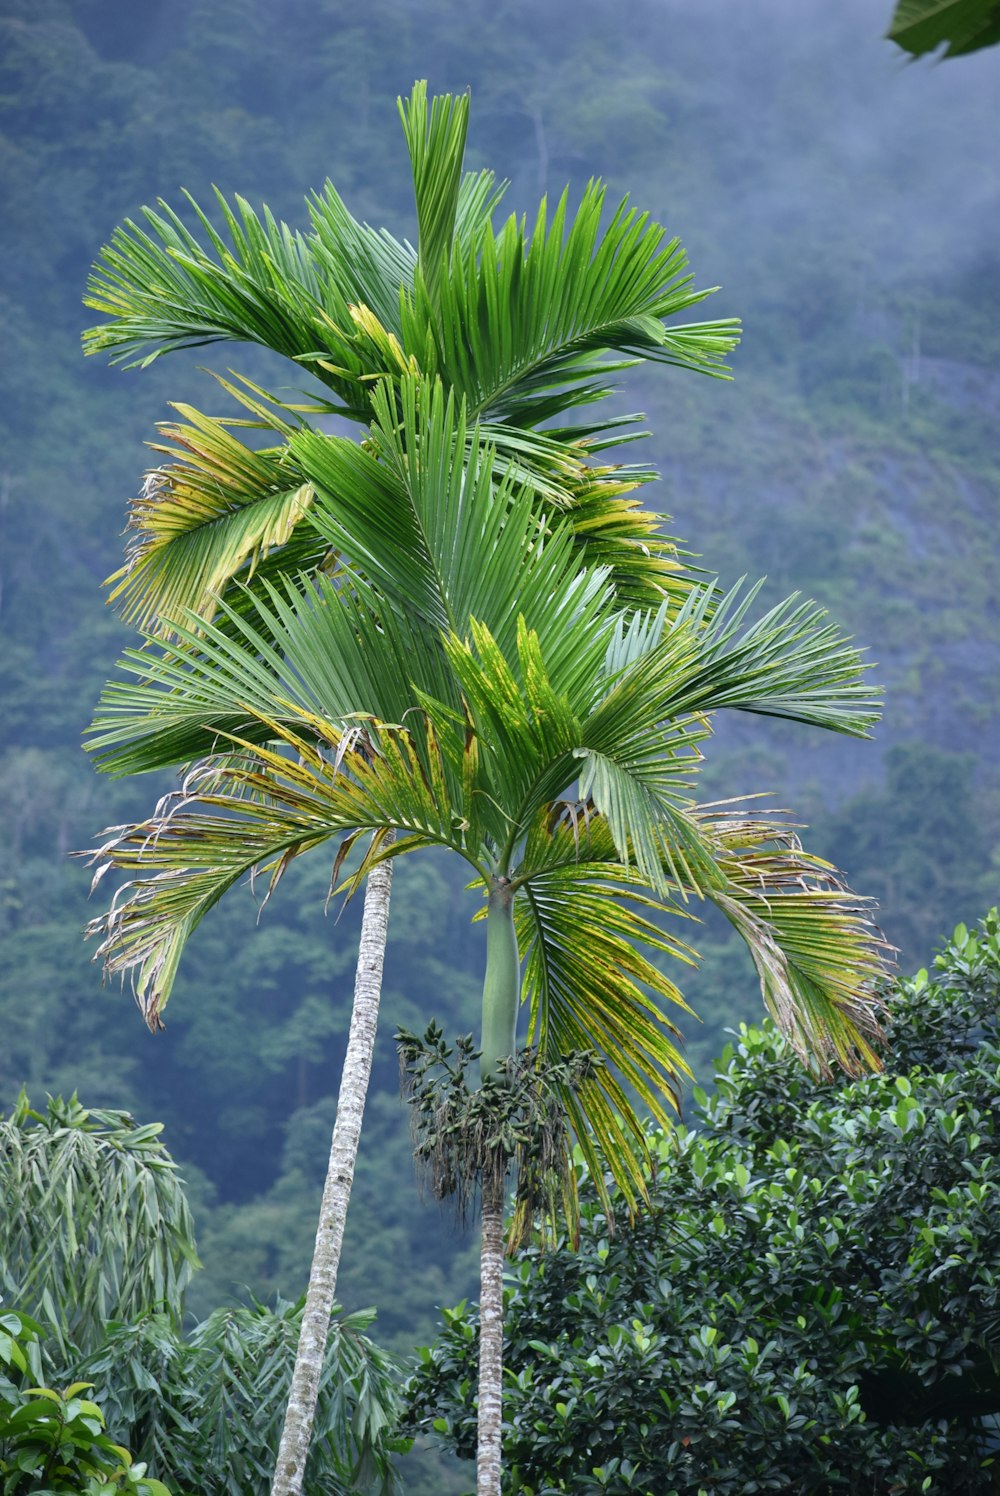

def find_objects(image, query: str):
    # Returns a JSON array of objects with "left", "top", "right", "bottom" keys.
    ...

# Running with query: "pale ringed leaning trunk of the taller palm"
[{"left": 271, "top": 843, "right": 392, "bottom": 1496}]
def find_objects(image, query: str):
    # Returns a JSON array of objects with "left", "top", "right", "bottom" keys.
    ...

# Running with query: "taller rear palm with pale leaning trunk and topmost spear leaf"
[{"left": 85, "top": 84, "right": 735, "bottom": 1496}]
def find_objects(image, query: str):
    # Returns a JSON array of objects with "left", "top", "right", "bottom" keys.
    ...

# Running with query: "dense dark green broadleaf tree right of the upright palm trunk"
[{"left": 410, "top": 910, "right": 1000, "bottom": 1496}]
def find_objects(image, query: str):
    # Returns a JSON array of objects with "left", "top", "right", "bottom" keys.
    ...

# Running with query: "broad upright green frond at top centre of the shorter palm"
[{"left": 292, "top": 375, "right": 612, "bottom": 651}]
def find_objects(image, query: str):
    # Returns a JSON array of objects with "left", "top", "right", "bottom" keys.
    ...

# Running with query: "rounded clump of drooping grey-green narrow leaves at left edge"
[{"left": 0, "top": 1094, "right": 198, "bottom": 1363}]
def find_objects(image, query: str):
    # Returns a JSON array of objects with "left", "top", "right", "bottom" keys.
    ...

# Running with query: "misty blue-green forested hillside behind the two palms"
[{"left": 0, "top": 0, "right": 1000, "bottom": 1412}]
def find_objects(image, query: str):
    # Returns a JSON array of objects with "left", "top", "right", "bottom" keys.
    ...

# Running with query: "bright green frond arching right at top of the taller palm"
[{"left": 403, "top": 183, "right": 737, "bottom": 425}]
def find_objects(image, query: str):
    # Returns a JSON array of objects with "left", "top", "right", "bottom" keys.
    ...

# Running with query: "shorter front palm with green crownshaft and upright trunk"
[{"left": 91, "top": 374, "right": 880, "bottom": 1492}]
